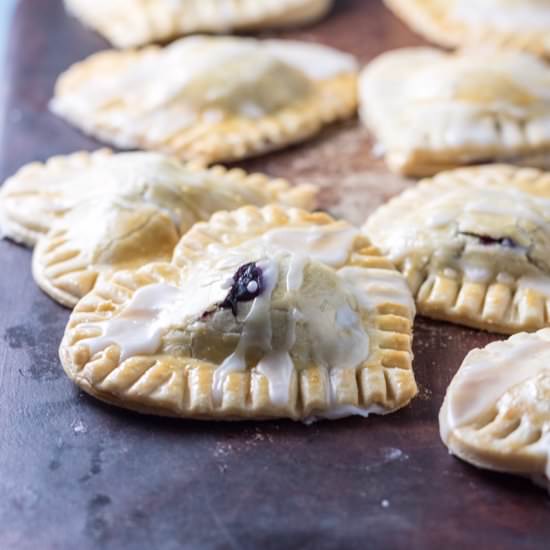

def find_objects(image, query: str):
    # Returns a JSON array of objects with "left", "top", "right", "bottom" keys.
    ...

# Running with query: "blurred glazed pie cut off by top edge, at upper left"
[{"left": 65, "top": 0, "right": 333, "bottom": 48}]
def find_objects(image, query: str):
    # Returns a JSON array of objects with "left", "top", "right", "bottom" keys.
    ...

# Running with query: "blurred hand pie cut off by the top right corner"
[{"left": 385, "top": 0, "right": 550, "bottom": 56}]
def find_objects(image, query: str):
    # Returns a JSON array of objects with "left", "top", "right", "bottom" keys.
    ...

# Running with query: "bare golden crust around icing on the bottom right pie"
[{"left": 439, "top": 329, "right": 550, "bottom": 486}]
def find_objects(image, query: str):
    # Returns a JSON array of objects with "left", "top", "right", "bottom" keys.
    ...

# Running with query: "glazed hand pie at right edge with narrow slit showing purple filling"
[{"left": 365, "top": 165, "right": 550, "bottom": 334}]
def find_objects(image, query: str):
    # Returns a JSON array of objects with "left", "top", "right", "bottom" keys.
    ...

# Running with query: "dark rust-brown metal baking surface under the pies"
[{"left": 0, "top": 0, "right": 550, "bottom": 550}]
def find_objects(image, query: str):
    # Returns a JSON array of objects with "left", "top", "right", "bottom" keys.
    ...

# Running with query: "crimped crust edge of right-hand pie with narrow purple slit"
[{"left": 365, "top": 165, "right": 550, "bottom": 334}]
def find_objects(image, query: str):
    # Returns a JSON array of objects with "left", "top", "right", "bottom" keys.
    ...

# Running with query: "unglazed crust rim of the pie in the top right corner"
[{"left": 384, "top": 0, "right": 550, "bottom": 57}]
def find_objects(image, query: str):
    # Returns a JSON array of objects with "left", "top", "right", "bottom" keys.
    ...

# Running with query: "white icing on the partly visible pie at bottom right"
[{"left": 444, "top": 329, "right": 550, "bottom": 439}]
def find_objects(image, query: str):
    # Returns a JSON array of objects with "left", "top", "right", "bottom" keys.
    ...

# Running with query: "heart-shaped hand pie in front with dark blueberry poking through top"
[{"left": 60, "top": 206, "right": 417, "bottom": 421}]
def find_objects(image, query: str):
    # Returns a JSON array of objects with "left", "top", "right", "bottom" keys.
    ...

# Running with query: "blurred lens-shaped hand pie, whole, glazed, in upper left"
[{"left": 51, "top": 36, "right": 357, "bottom": 163}]
